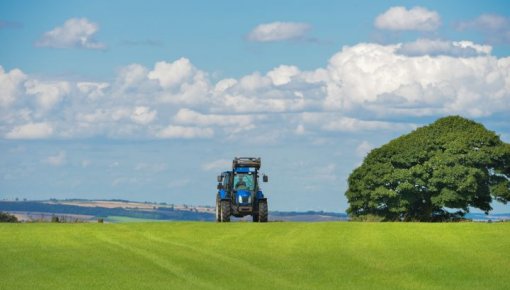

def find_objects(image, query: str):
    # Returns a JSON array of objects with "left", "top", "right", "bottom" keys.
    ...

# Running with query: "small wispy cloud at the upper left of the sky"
[{"left": 36, "top": 18, "right": 106, "bottom": 49}]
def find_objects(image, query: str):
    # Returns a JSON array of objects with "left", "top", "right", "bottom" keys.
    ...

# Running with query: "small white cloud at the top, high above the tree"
[{"left": 374, "top": 6, "right": 441, "bottom": 31}]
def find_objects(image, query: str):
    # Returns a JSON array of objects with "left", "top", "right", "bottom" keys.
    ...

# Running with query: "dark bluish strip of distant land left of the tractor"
[{"left": 0, "top": 201, "right": 214, "bottom": 221}]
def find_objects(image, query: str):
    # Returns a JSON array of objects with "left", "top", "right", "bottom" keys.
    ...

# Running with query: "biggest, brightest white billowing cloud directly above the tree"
[{"left": 325, "top": 44, "right": 510, "bottom": 117}]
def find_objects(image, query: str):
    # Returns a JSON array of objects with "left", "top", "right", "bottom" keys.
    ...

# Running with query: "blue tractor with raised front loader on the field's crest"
[{"left": 216, "top": 157, "right": 268, "bottom": 223}]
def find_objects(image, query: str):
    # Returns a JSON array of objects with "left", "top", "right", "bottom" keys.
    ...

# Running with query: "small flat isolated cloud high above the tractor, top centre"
[{"left": 248, "top": 22, "right": 310, "bottom": 42}]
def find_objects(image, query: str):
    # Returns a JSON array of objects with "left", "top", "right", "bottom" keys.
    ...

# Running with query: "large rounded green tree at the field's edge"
[{"left": 345, "top": 116, "right": 510, "bottom": 221}]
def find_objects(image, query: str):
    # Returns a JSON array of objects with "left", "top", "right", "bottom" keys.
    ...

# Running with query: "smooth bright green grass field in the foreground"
[{"left": 0, "top": 222, "right": 510, "bottom": 289}]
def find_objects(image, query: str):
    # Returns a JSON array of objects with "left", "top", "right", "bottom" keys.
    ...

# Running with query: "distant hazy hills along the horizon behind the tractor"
[{"left": 0, "top": 199, "right": 347, "bottom": 222}]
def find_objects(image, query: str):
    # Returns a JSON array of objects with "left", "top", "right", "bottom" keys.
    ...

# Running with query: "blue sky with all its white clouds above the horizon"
[{"left": 0, "top": 0, "right": 510, "bottom": 213}]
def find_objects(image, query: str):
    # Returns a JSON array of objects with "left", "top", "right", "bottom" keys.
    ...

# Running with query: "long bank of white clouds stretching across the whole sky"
[{"left": 0, "top": 39, "right": 510, "bottom": 143}]
